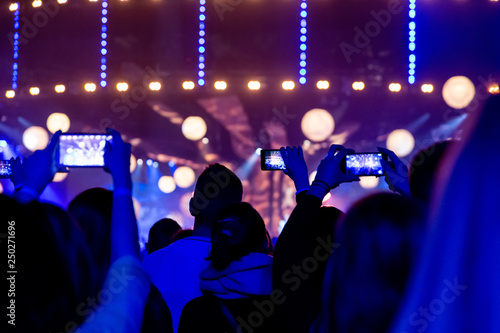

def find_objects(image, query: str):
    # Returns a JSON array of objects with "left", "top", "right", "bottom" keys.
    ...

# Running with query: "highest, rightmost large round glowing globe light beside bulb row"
[{"left": 442, "top": 76, "right": 476, "bottom": 109}]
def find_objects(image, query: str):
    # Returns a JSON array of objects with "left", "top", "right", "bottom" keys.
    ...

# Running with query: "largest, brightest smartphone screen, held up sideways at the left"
[{"left": 56, "top": 133, "right": 112, "bottom": 168}]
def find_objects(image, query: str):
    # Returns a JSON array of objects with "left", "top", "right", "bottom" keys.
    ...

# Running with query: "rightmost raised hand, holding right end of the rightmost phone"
[{"left": 377, "top": 147, "right": 410, "bottom": 196}]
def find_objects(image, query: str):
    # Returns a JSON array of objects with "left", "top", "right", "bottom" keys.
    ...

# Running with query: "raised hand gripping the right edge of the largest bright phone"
[{"left": 104, "top": 128, "right": 132, "bottom": 189}]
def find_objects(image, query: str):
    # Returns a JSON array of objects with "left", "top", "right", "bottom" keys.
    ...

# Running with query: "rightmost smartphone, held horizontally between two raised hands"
[{"left": 341, "top": 153, "right": 387, "bottom": 176}]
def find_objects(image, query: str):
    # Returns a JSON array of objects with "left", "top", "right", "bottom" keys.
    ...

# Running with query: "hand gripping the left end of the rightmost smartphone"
[{"left": 315, "top": 145, "right": 359, "bottom": 189}]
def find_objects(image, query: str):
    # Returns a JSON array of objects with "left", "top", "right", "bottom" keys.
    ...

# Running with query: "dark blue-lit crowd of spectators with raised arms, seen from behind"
[{"left": 0, "top": 96, "right": 500, "bottom": 333}]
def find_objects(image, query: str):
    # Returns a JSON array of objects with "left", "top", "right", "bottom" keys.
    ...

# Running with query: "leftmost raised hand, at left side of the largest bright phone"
[{"left": 18, "top": 131, "right": 61, "bottom": 195}]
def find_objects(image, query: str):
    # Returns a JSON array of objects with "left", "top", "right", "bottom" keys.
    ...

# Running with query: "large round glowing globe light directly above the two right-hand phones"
[{"left": 300, "top": 109, "right": 335, "bottom": 142}]
